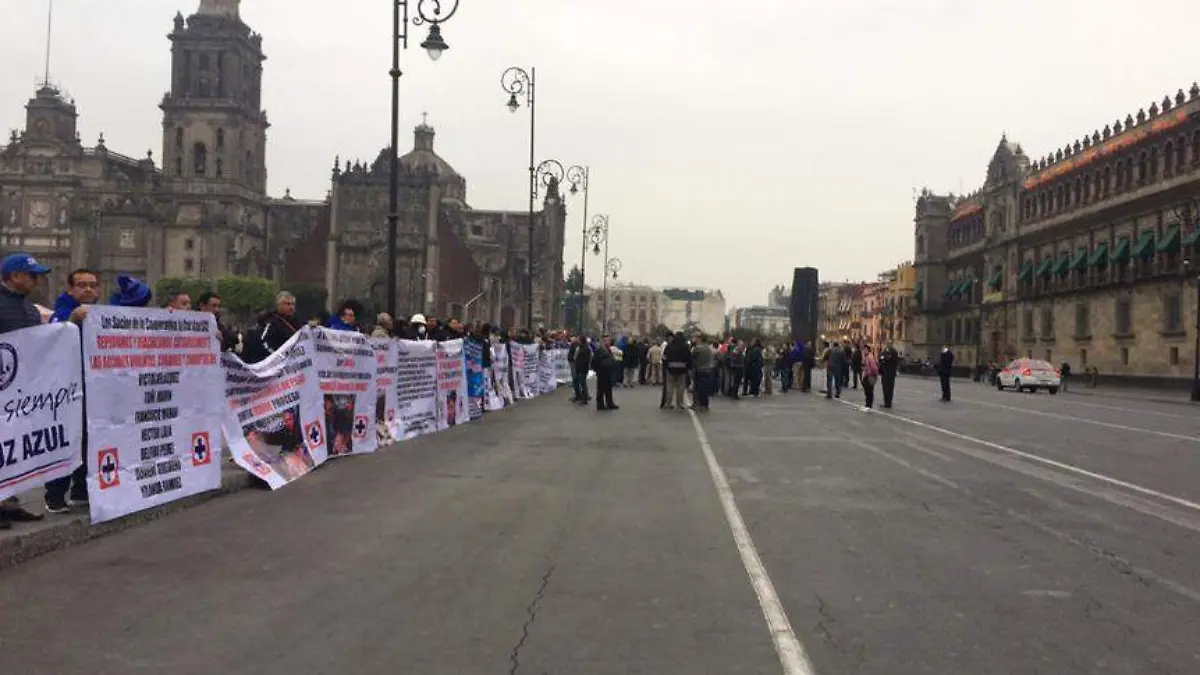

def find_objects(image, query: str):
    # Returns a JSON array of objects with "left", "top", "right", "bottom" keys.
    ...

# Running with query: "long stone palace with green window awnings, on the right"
[{"left": 910, "top": 84, "right": 1200, "bottom": 378}]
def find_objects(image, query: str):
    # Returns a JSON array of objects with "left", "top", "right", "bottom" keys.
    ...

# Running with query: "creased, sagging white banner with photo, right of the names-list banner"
[{"left": 221, "top": 328, "right": 329, "bottom": 490}]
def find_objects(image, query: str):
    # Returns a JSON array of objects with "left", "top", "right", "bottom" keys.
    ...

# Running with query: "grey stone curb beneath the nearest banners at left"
[{"left": 0, "top": 466, "right": 252, "bottom": 571}]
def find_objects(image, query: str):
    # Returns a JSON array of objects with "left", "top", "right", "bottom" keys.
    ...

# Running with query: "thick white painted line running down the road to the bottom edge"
[{"left": 688, "top": 410, "right": 816, "bottom": 675}]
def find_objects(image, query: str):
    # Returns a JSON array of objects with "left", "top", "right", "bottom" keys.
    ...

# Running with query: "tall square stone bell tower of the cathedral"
[{"left": 160, "top": 0, "right": 270, "bottom": 195}]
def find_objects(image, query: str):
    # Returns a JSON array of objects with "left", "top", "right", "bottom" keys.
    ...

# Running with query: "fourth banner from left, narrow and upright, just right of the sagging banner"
[{"left": 313, "top": 328, "right": 379, "bottom": 456}]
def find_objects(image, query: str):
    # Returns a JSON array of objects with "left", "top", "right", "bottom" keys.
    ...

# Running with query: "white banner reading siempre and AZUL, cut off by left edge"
[{"left": 0, "top": 323, "right": 83, "bottom": 500}]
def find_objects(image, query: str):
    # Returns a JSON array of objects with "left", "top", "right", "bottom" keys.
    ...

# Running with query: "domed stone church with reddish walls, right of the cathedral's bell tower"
[{"left": 314, "top": 123, "right": 566, "bottom": 327}]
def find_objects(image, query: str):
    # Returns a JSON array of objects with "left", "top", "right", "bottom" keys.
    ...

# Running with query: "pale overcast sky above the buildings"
[{"left": 0, "top": 0, "right": 1200, "bottom": 305}]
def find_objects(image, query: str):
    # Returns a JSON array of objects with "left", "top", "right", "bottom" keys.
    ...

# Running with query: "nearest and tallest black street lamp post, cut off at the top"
[{"left": 386, "top": 0, "right": 458, "bottom": 316}]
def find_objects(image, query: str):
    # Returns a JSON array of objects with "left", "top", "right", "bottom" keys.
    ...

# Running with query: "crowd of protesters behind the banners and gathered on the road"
[{"left": 0, "top": 248, "right": 954, "bottom": 530}]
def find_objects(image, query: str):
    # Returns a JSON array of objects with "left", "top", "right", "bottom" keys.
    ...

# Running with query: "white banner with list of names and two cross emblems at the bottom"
[{"left": 83, "top": 305, "right": 226, "bottom": 522}]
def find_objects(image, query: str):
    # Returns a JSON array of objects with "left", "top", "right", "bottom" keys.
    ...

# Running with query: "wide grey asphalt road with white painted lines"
[{"left": 0, "top": 380, "right": 1200, "bottom": 675}]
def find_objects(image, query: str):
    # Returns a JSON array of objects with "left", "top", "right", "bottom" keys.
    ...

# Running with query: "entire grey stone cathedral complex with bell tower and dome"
[{"left": 0, "top": 0, "right": 566, "bottom": 325}]
